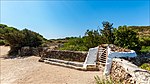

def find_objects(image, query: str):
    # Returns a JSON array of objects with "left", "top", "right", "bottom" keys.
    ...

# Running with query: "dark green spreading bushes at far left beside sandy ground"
[{"left": 0, "top": 24, "right": 45, "bottom": 55}]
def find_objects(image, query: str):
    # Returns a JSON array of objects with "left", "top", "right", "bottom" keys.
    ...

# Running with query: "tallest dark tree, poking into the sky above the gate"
[{"left": 100, "top": 21, "right": 114, "bottom": 44}]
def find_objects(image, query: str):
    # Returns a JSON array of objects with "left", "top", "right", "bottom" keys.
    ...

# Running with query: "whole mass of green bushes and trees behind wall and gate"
[{"left": 61, "top": 21, "right": 146, "bottom": 51}]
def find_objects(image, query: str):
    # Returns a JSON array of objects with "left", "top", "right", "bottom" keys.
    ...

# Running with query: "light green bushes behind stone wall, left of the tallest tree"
[{"left": 60, "top": 30, "right": 104, "bottom": 51}]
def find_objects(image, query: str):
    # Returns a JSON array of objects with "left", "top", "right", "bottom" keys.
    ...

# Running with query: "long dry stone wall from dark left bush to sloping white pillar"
[{"left": 18, "top": 47, "right": 87, "bottom": 62}]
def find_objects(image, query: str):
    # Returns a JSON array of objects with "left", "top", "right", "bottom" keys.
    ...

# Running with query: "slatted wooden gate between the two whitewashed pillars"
[{"left": 97, "top": 46, "right": 107, "bottom": 71}]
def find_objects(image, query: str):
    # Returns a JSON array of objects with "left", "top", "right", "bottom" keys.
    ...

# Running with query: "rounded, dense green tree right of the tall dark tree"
[{"left": 114, "top": 26, "right": 141, "bottom": 50}]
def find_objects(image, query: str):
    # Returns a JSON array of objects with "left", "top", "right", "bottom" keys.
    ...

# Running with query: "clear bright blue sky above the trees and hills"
[{"left": 0, "top": 0, "right": 150, "bottom": 39}]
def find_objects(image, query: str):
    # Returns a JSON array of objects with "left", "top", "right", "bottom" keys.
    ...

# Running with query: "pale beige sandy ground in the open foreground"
[{"left": 0, "top": 46, "right": 101, "bottom": 84}]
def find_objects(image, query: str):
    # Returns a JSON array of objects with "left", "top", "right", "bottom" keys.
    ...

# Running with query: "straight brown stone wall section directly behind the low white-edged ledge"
[{"left": 42, "top": 49, "right": 87, "bottom": 62}]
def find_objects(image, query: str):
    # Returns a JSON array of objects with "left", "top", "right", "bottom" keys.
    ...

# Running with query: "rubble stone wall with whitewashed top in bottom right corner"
[{"left": 110, "top": 58, "right": 150, "bottom": 84}]
